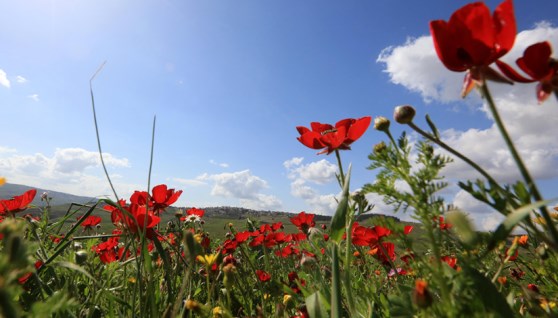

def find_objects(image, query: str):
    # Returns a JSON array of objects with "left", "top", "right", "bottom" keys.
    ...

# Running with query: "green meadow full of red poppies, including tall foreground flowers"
[{"left": 0, "top": 0, "right": 558, "bottom": 317}]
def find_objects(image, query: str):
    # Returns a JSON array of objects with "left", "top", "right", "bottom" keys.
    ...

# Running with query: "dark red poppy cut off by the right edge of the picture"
[{"left": 496, "top": 41, "right": 558, "bottom": 103}]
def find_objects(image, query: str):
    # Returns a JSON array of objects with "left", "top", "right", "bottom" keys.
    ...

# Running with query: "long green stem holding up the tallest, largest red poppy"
[{"left": 480, "top": 82, "right": 558, "bottom": 244}]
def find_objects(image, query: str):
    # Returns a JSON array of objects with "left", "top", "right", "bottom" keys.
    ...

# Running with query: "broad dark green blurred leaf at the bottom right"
[{"left": 465, "top": 267, "right": 515, "bottom": 317}]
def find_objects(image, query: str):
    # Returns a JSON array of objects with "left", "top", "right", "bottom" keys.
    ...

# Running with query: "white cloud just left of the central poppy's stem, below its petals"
[{"left": 283, "top": 157, "right": 337, "bottom": 215}]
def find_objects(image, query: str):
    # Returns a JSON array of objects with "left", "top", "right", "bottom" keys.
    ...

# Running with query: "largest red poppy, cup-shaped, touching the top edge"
[{"left": 430, "top": 0, "right": 516, "bottom": 95}]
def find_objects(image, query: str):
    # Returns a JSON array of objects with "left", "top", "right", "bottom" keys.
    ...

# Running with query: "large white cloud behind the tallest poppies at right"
[{"left": 377, "top": 22, "right": 558, "bottom": 230}]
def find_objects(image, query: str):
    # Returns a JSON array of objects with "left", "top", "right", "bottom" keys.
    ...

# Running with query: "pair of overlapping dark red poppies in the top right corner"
[{"left": 430, "top": 0, "right": 558, "bottom": 103}]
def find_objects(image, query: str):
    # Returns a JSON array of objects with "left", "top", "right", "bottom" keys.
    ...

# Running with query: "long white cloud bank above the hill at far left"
[{"left": 0, "top": 148, "right": 136, "bottom": 196}]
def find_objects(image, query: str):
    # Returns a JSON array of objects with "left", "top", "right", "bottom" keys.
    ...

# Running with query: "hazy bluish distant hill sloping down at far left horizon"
[{"left": 0, "top": 183, "right": 97, "bottom": 206}]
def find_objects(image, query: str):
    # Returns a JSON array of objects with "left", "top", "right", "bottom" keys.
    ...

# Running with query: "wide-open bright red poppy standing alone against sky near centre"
[{"left": 296, "top": 116, "right": 372, "bottom": 155}]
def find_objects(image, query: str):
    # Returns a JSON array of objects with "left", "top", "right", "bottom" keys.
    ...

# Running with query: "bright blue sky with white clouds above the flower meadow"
[{"left": 0, "top": 0, "right": 558, "bottom": 226}]
